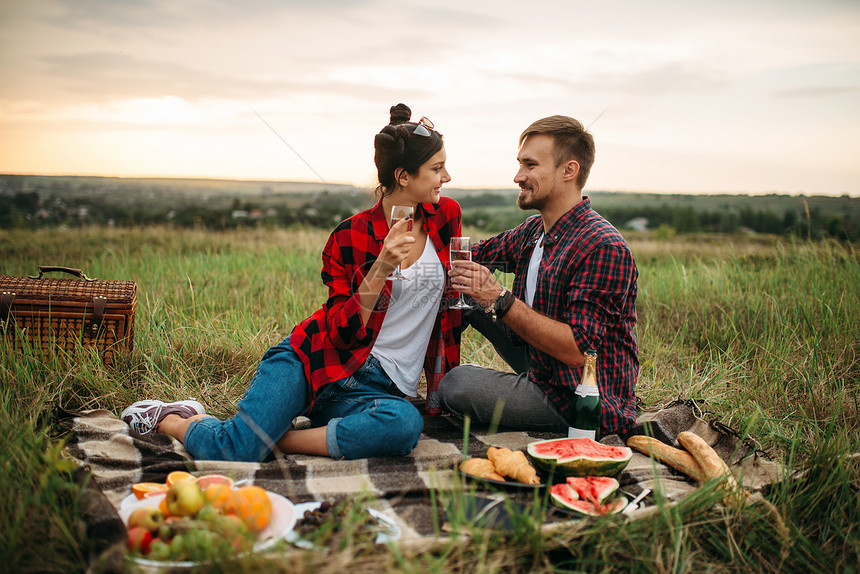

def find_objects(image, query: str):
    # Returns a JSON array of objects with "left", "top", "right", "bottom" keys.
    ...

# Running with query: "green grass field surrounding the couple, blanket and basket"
[{"left": 0, "top": 228, "right": 860, "bottom": 573}]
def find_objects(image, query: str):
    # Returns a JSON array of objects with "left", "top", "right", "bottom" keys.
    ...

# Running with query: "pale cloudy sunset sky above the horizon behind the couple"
[{"left": 0, "top": 0, "right": 860, "bottom": 196}]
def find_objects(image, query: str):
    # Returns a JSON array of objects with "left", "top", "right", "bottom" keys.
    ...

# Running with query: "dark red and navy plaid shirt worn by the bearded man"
[{"left": 472, "top": 197, "right": 639, "bottom": 434}]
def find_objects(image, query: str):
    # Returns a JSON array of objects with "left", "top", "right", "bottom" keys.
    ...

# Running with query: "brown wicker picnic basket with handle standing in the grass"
[{"left": 0, "top": 266, "right": 137, "bottom": 366}]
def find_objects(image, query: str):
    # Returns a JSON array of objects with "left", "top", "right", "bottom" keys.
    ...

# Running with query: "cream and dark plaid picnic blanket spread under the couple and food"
[{"left": 56, "top": 399, "right": 781, "bottom": 560}]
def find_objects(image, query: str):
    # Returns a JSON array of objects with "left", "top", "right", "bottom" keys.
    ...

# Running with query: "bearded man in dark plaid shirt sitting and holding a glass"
[{"left": 439, "top": 116, "right": 639, "bottom": 434}]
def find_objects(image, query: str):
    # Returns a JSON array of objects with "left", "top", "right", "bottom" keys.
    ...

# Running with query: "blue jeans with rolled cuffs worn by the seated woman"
[{"left": 184, "top": 337, "right": 424, "bottom": 462}]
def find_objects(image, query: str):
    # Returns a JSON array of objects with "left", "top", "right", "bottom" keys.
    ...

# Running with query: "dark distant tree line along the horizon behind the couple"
[{"left": 0, "top": 182, "right": 860, "bottom": 241}]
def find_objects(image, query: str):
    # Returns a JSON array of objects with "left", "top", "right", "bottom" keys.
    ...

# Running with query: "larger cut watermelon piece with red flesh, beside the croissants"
[{"left": 526, "top": 438, "right": 633, "bottom": 476}]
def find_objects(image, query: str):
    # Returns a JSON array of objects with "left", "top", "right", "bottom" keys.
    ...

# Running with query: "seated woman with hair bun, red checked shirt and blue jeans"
[{"left": 122, "top": 104, "right": 460, "bottom": 461}]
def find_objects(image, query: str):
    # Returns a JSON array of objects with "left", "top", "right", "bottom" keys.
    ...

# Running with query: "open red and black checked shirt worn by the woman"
[{"left": 290, "top": 197, "right": 461, "bottom": 414}]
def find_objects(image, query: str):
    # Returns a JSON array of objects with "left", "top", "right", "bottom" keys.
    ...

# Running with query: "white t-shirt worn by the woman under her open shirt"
[{"left": 371, "top": 237, "right": 446, "bottom": 397}]
